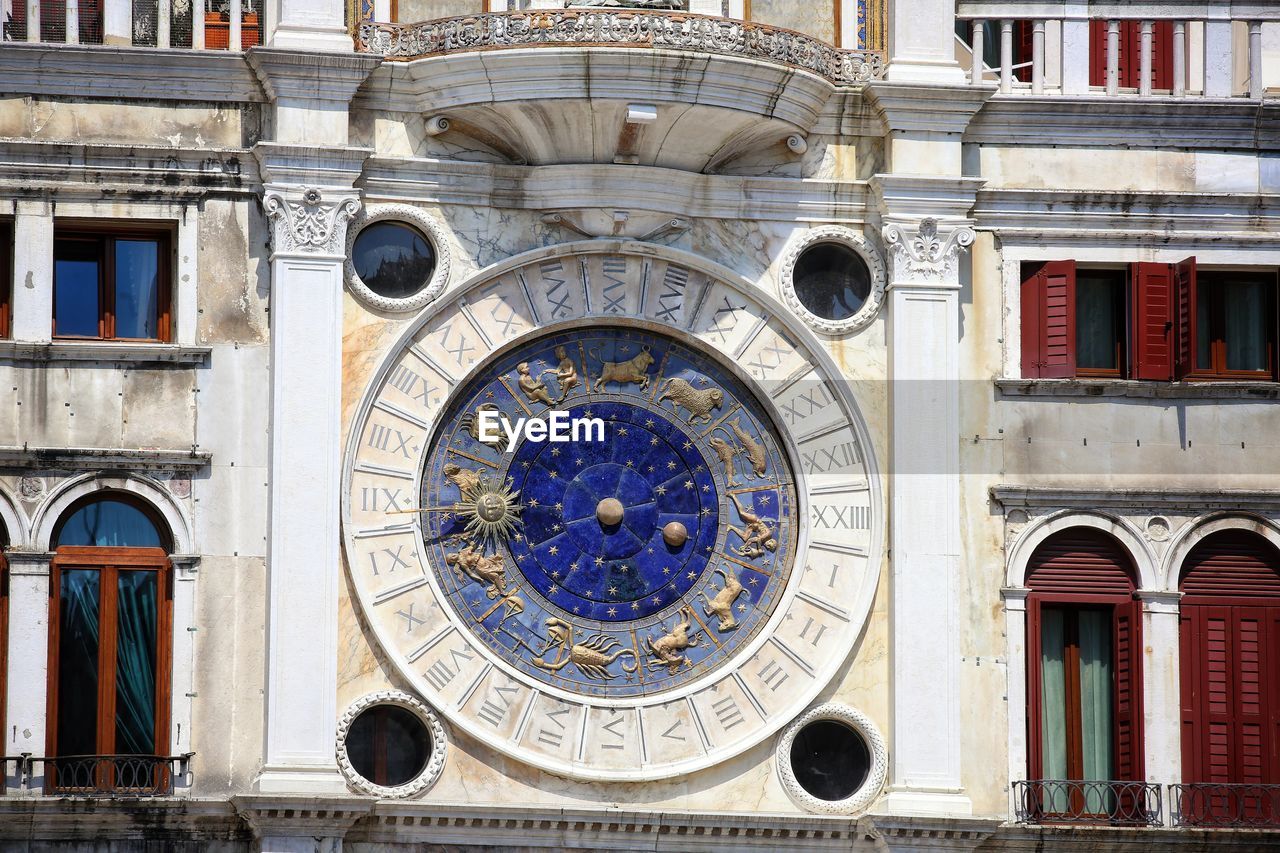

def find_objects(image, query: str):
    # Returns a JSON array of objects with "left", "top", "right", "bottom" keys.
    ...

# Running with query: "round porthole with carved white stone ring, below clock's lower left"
[{"left": 338, "top": 690, "right": 445, "bottom": 797}]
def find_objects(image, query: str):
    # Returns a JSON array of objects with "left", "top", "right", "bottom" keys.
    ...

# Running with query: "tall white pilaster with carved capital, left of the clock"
[{"left": 257, "top": 183, "right": 360, "bottom": 793}]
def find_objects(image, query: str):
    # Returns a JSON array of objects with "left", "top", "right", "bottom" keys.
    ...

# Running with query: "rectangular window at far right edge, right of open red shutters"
[{"left": 1193, "top": 272, "right": 1277, "bottom": 379}]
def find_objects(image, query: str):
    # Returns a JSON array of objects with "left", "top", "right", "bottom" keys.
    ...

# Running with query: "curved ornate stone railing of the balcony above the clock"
[{"left": 356, "top": 9, "right": 883, "bottom": 85}]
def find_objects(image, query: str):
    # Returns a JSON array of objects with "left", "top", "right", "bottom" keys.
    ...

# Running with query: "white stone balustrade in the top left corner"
[{"left": 0, "top": 0, "right": 264, "bottom": 51}]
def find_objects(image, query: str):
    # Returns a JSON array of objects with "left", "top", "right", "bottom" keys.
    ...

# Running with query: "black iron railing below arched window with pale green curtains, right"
[{"left": 1012, "top": 779, "right": 1164, "bottom": 826}]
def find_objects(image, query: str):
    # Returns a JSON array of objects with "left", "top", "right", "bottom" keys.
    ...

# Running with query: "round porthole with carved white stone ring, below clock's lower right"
[{"left": 776, "top": 702, "right": 888, "bottom": 815}]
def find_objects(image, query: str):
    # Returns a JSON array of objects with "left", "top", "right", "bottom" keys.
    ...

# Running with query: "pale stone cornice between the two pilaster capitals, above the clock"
[{"left": 361, "top": 156, "right": 868, "bottom": 223}]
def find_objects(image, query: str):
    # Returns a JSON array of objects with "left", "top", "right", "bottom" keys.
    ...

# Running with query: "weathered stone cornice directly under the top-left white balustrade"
[{"left": 0, "top": 41, "right": 266, "bottom": 104}]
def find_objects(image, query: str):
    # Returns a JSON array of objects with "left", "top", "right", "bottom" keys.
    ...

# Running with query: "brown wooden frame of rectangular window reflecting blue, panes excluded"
[{"left": 50, "top": 222, "right": 175, "bottom": 343}]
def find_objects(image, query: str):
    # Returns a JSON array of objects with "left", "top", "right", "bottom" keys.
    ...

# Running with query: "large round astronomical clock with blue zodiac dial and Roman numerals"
[{"left": 343, "top": 241, "right": 881, "bottom": 781}]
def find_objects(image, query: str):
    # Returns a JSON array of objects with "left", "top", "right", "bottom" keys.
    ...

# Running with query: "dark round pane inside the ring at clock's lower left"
[{"left": 347, "top": 704, "right": 431, "bottom": 788}]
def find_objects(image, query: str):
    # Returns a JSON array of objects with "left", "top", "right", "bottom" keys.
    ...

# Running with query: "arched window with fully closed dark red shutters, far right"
[{"left": 1179, "top": 530, "right": 1280, "bottom": 820}]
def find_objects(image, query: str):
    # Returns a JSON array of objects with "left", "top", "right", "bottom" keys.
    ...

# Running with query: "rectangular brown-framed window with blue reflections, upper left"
[{"left": 54, "top": 229, "right": 172, "bottom": 341}]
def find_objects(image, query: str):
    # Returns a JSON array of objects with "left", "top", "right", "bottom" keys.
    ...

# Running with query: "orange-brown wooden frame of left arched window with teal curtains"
[{"left": 45, "top": 546, "right": 173, "bottom": 793}]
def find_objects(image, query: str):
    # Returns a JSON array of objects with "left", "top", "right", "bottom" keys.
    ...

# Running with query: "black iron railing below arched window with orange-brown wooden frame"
[{"left": 4, "top": 752, "right": 196, "bottom": 797}]
